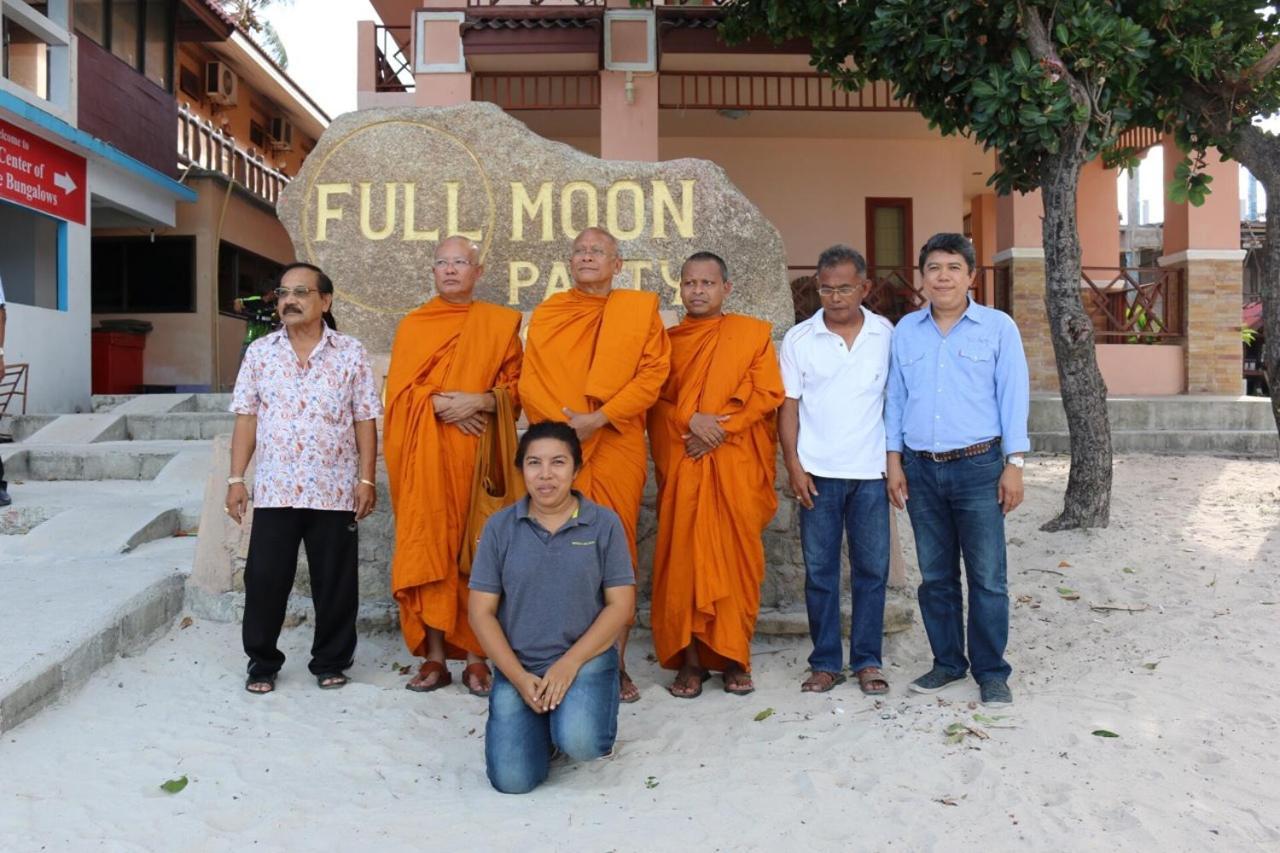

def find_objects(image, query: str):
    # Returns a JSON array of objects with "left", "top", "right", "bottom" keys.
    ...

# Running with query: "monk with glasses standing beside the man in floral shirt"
[{"left": 383, "top": 237, "right": 521, "bottom": 695}]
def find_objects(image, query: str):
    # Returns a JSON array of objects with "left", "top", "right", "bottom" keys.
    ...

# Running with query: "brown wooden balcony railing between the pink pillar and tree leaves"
[{"left": 658, "top": 72, "right": 914, "bottom": 113}]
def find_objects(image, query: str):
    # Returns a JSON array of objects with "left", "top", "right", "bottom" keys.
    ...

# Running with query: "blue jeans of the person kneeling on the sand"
[{"left": 484, "top": 648, "right": 618, "bottom": 794}]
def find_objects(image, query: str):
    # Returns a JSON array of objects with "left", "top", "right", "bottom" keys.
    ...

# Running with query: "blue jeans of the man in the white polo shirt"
[{"left": 800, "top": 476, "right": 888, "bottom": 672}]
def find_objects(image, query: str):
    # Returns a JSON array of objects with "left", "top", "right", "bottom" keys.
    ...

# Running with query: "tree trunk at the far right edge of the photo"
[{"left": 1230, "top": 124, "right": 1280, "bottom": 445}]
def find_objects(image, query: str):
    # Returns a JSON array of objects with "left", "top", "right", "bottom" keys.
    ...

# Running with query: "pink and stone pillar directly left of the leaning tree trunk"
[{"left": 992, "top": 191, "right": 1059, "bottom": 393}]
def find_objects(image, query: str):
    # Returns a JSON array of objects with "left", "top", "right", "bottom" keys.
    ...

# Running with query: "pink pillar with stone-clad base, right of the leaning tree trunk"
[{"left": 1160, "top": 137, "right": 1244, "bottom": 397}]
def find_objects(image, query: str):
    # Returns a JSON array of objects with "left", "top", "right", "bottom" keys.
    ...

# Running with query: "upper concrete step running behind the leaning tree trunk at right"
[{"left": 1028, "top": 396, "right": 1275, "bottom": 433}]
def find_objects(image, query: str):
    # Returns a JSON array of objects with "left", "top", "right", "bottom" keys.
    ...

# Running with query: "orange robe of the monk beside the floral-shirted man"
[{"left": 383, "top": 297, "right": 520, "bottom": 657}]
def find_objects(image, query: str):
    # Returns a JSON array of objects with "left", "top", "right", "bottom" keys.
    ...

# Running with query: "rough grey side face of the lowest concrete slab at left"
[{"left": 0, "top": 573, "right": 186, "bottom": 734}]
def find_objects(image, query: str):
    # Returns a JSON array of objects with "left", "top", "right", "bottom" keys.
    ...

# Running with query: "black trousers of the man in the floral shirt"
[{"left": 243, "top": 507, "right": 360, "bottom": 676}]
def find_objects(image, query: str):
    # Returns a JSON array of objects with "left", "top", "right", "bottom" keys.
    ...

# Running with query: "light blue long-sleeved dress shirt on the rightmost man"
[{"left": 884, "top": 300, "right": 1032, "bottom": 456}]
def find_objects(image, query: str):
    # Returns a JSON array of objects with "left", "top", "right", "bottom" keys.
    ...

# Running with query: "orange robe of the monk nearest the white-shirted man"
[{"left": 649, "top": 314, "right": 783, "bottom": 670}]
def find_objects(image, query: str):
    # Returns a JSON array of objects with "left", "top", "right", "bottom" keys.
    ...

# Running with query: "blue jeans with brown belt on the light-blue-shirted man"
[{"left": 902, "top": 444, "right": 1012, "bottom": 683}]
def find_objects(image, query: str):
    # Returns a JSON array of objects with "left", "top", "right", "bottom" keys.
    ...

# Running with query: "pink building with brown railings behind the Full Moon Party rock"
[{"left": 356, "top": 0, "right": 1244, "bottom": 396}]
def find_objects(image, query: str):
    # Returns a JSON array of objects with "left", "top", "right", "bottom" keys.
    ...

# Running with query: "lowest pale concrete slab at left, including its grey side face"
[{"left": 0, "top": 538, "right": 195, "bottom": 733}]
